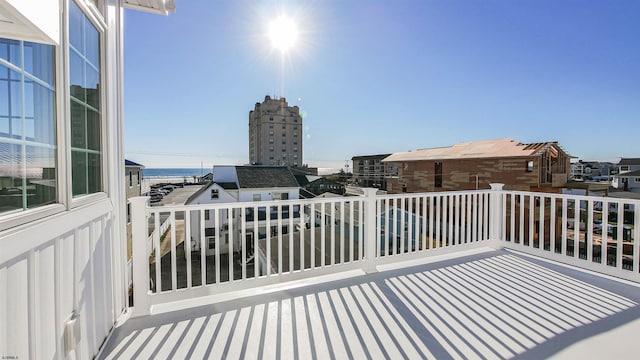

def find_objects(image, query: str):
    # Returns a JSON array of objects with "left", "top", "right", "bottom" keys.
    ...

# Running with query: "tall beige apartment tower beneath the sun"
[{"left": 249, "top": 95, "right": 302, "bottom": 167}]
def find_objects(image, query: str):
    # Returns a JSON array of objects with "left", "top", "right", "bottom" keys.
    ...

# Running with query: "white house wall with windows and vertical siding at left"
[{"left": 0, "top": 0, "right": 173, "bottom": 359}]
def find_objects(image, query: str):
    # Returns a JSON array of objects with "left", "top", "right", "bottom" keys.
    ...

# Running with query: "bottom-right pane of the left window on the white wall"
[{"left": 26, "top": 146, "right": 56, "bottom": 208}]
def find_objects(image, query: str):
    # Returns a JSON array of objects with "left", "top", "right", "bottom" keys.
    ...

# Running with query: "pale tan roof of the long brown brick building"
[{"left": 383, "top": 139, "right": 564, "bottom": 162}]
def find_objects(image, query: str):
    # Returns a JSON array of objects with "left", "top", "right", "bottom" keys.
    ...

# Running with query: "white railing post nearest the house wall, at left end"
[{"left": 129, "top": 196, "right": 151, "bottom": 316}]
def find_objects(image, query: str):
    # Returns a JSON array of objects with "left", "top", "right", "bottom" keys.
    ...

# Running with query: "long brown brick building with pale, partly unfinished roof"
[{"left": 383, "top": 139, "right": 571, "bottom": 193}]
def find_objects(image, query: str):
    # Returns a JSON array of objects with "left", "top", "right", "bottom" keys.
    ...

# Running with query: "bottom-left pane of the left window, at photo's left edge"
[{"left": 0, "top": 142, "right": 23, "bottom": 212}]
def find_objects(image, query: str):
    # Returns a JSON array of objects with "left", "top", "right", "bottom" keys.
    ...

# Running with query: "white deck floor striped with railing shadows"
[{"left": 100, "top": 251, "right": 640, "bottom": 359}]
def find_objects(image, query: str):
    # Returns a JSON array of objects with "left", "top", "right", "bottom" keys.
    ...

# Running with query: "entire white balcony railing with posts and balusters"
[{"left": 131, "top": 184, "right": 640, "bottom": 315}]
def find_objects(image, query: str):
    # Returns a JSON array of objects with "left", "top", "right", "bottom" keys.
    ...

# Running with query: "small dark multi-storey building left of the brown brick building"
[{"left": 351, "top": 154, "right": 398, "bottom": 190}]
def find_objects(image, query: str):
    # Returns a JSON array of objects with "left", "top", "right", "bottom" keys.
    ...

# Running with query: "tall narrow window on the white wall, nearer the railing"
[{"left": 69, "top": 1, "right": 102, "bottom": 197}]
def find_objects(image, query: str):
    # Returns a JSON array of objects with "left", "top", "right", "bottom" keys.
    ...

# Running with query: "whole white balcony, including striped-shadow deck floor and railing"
[{"left": 99, "top": 186, "right": 640, "bottom": 359}]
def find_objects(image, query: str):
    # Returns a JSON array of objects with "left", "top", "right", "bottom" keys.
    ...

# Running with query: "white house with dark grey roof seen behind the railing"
[{"left": 185, "top": 166, "right": 300, "bottom": 255}]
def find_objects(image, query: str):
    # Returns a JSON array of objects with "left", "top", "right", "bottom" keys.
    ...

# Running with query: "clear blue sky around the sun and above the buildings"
[{"left": 125, "top": 0, "right": 640, "bottom": 168}]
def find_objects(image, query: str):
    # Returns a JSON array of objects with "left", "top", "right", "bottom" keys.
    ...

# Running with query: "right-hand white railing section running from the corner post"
[{"left": 500, "top": 191, "right": 640, "bottom": 282}]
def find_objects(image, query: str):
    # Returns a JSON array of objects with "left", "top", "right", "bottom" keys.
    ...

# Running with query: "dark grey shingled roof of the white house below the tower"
[{"left": 236, "top": 166, "right": 299, "bottom": 189}]
